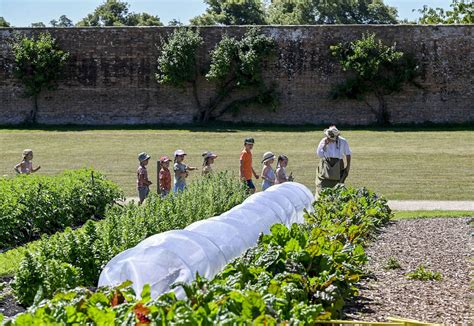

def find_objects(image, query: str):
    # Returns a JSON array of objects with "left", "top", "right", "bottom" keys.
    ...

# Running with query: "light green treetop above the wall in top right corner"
[{"left": 418, "top": 0, "right": 474, "bottom": 24}]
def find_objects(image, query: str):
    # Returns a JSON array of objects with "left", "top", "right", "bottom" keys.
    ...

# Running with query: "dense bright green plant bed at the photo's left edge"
[{"left": 0, "top": 169, "right": 123, "bottom": 248}]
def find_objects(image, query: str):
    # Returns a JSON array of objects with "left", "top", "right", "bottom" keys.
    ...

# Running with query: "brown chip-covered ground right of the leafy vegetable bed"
[{"left": 345, "top": 218, "right": 474, "bottom": 325}]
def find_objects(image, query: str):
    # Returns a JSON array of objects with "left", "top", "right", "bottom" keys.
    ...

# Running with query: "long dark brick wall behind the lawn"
[{"left": 0, "top": 25, "right": 474, "bottom": 125}]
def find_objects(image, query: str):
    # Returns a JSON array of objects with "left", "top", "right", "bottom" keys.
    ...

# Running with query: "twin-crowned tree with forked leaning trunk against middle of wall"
[{"left": 156, "top": 28, "right": 276, "bottom": 122}]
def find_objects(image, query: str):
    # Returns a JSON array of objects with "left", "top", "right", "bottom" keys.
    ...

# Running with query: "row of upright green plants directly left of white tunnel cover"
[{"left": 12, "top": 173, "right": 246, "bottom": 305}]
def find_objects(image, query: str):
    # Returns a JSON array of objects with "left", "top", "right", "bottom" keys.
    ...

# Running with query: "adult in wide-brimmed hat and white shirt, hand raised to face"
[{"left": 315, "top": 125, "right": 352, "bottom": 198}]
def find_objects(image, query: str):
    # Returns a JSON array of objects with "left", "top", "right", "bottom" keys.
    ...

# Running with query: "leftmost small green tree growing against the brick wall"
[{"left": 12, "top": 33, "right": 69, "bottom": 123}]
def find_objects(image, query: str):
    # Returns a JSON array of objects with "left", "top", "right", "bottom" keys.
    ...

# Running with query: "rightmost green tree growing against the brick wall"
[{"left": 330, "top": 34, "right": 419, "bottom": 125}]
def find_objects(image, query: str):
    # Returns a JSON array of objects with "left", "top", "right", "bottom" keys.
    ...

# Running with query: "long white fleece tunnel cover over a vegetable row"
[{"left": 99, "top": 182, "right": 314, "bottom": 298}]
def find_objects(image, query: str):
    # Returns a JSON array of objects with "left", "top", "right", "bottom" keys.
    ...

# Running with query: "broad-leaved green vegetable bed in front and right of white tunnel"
[{"left": 7, "top": 189, "right": 391, "bottom": 325}]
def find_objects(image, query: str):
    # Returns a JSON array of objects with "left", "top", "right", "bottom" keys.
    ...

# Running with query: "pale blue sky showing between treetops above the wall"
[{"left": 0, "top": 0, "right": 451, "bottom": 27}]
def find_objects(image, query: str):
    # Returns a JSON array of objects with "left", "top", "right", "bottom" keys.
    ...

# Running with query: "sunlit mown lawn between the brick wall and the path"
[{"left": 0, "top": 127, "right": 474, "bottom": 200}]
